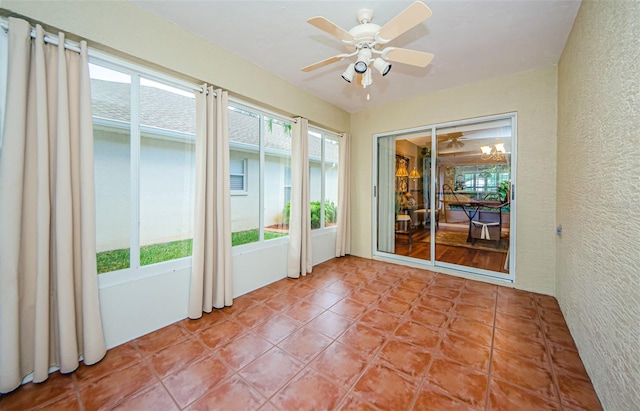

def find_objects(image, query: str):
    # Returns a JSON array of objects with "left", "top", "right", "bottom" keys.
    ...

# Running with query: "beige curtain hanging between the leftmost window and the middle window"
[{"left": 189, "top": 85, "right": 233, "bottom": 318}]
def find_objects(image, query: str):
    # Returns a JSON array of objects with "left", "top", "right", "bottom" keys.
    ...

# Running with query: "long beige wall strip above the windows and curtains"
[{"left": 0, "top": 0, "right": 349, "bottom": 132}]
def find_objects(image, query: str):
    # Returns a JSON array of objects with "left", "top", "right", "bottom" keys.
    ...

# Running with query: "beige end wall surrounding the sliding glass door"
[{"left": 351, "top": 66, "right": 557, "bottom": 294}]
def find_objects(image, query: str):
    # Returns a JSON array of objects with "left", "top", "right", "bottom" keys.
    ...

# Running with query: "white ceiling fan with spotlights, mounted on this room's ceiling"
[{"left": 301, "top": 1, "right": 433, "bottom": 88}]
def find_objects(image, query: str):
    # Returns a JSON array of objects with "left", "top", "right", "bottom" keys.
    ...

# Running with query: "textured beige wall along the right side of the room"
[{"left": 556, "top": 1, "right": 640, "bottom": 410}]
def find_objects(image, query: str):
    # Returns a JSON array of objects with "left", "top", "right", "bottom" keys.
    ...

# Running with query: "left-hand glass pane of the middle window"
[{"left": 229, "top": 106, "right": 260, "bottom": 246}]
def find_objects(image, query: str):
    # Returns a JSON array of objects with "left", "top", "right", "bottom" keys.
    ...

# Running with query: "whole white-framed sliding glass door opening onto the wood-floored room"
[{"left": 374, "top": 115, "right": 516, "bottom": 279}]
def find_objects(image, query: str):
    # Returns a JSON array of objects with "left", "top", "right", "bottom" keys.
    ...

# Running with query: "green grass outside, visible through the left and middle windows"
[{"left": 96, "top": 229, "right": 287, "bottom": 274}]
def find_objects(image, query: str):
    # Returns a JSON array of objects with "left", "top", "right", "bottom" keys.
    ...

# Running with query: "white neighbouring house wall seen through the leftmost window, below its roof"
[{"left": 94, "top": 129, "right": 195, "bottom": 252}]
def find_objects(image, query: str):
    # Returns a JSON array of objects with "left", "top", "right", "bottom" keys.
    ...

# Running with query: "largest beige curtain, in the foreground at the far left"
[{"left": 0, "top": 18, "right": 106, "bottom": 392}]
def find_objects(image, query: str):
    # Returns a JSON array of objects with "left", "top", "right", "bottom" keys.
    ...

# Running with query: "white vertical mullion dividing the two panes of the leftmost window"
[{"left": 129, "top": 75, "right": 140, "bottom": 268}]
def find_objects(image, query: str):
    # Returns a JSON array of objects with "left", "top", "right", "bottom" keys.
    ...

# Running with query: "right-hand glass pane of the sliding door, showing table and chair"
[{"left": 435, "top": 119, "right": 512, "bottom": 274}]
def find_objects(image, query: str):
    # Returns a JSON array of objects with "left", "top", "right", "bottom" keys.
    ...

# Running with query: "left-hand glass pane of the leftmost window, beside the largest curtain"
[{"left": 89, "top": 64, "right": 131, "bottom": 274}]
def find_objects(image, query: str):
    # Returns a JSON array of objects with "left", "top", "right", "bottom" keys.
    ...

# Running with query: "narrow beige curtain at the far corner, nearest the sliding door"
[{"left": 336, "top": 133, "right": 351, "bottom": 257}]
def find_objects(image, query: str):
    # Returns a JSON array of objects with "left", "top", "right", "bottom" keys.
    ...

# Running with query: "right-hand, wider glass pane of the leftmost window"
[{"left": 140, "top": 79, "right": 196, "bottom": 266}]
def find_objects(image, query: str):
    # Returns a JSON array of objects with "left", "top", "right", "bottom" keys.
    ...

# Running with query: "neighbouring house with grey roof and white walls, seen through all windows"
[{"left": 91, "top": 79, "right": 338, "bottom": 252}]
